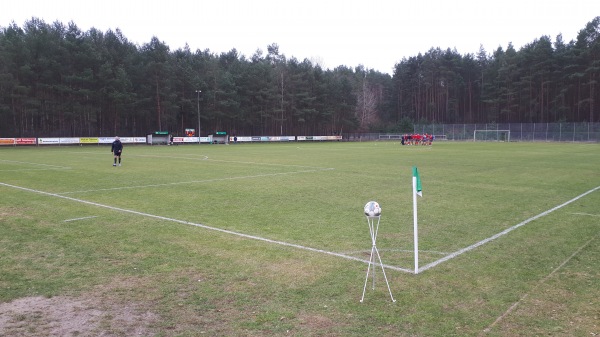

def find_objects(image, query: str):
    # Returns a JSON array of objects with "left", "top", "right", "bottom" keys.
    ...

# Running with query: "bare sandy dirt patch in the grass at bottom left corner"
[{"left": 0, "top": 296, "right": 158, "bottom": 337}]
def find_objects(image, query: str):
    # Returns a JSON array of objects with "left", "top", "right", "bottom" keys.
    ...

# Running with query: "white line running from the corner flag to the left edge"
[{"left": 0, "top": 182, "right": 412, "bottom": 273}]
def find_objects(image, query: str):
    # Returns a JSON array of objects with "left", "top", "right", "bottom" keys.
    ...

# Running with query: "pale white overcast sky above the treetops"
[{"left": 0, "top": 0, "right": 600, "bottom": 74}]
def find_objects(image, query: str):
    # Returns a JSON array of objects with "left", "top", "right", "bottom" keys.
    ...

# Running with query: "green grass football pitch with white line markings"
[{"left": 0, "top": 142, "right": 600, "bottom": 336}]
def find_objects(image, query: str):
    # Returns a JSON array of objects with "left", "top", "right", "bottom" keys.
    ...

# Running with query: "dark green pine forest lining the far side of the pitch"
[{"left": 0, "top": 16, "right": 600, "bottom": 137}]
